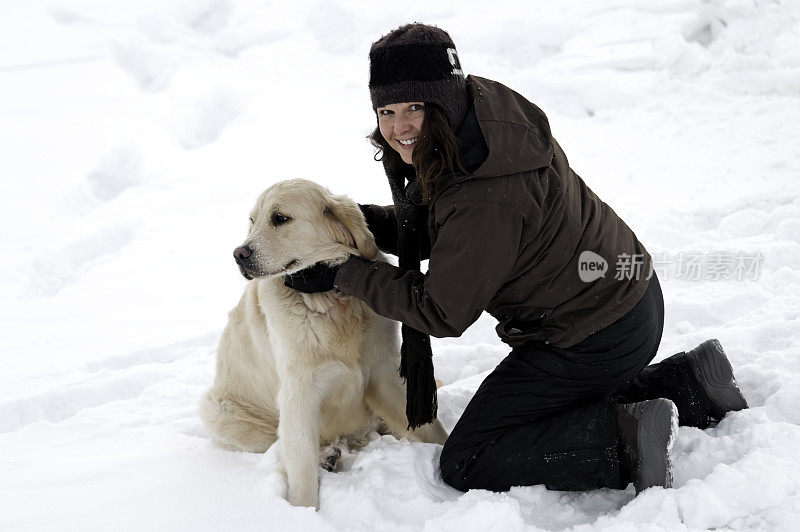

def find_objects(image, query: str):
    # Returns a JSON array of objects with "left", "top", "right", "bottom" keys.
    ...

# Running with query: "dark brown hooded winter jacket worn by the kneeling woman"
[{"left": 336, "top": 76, "right": 651, "bottom": 348}]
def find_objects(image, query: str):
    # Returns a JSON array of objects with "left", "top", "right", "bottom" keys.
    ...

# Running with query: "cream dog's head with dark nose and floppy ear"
[{"left": 233, "top": 179, "right": 378, "bottom": 279}]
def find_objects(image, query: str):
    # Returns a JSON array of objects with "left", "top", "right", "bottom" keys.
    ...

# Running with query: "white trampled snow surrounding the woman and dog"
[{"left": 0, "top": 0, "right": 800, "bottom": 531}]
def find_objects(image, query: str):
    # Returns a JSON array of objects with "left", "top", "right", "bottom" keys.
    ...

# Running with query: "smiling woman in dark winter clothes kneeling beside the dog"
[{"left": 286, "top": 20, "right": 747, "bottom": 493}]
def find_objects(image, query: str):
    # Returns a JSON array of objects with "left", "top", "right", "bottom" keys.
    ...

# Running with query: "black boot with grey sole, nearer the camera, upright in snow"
[{"left": 617, "top": 399, "right": 678, "bottom": 494}]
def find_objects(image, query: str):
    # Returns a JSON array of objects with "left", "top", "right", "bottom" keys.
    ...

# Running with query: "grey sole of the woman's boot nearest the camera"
[{"left": 624, "top": 399, "right": 678, "bottom": 494}]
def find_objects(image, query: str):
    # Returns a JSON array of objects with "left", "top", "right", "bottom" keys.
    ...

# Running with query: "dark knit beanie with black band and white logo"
[{"left": 369, "top": 23, "right": 469, "bottom": 131}]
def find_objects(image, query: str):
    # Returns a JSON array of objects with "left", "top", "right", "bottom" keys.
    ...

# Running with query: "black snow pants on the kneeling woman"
[{"left": 440, "top": 274, "right": 705, "bottom": 491}]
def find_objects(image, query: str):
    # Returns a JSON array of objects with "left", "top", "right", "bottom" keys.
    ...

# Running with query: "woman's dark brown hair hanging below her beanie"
[{"left": 367, "top": 102, "right": 467, "bottom": 203}]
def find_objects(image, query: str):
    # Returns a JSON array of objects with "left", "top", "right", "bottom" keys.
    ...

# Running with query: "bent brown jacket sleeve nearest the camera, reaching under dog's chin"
[{"left": 335, "top": 201, "right": 524, "bottom": 338}]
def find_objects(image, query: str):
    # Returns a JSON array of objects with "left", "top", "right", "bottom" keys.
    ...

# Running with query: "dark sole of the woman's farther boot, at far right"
[{"left": 688, "top": 339, "right": 747, "bottom": 421}]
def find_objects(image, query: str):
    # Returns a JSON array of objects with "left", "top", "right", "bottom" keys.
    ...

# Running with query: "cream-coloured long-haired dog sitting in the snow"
[{"left": 200, "top": 179, "right": 447, "bottom": 507}]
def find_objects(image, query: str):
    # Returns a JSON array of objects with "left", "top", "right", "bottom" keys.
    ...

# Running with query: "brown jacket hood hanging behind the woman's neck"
[{"left": 455, "top": 75, "right": 553, "bottom": 181}]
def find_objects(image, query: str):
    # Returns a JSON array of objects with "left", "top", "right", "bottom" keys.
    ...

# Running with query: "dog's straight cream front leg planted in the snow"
[{"left": 278, "top": 367, "right": 320, "bottom": 508}]
